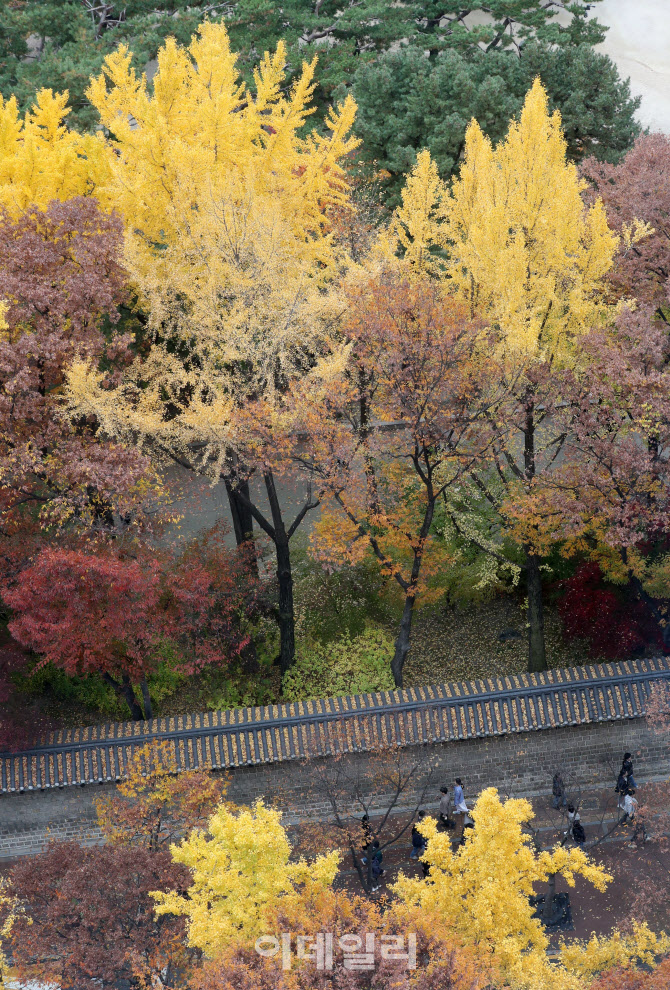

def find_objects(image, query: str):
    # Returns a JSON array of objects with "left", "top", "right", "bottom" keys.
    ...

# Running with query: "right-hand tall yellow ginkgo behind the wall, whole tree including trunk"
[{"left": 382, "top": 79, "right": 624, "bottom": 670}]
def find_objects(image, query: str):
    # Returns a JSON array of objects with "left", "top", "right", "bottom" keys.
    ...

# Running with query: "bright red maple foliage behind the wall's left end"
[{"left": 3, "top": 530, "right": 254, "bottom": 718}]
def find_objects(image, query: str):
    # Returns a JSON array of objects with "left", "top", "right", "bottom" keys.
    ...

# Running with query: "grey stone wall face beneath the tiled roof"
[{"left": 0, "top": 719, "right": 670, "bottom": 859}]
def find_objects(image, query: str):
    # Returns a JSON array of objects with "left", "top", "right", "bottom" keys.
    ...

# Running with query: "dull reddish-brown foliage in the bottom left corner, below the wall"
[{"left": 3, "top": 842, "right": 190, "bottom": 990}]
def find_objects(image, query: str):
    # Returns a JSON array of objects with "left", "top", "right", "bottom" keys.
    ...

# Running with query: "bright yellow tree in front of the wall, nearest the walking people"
[{"left": 393, "top": 787, "right": 611, "bottom": 990}]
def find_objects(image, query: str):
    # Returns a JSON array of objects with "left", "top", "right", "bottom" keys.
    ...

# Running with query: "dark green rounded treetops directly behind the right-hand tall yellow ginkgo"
[{"left": 354, "top": 43, "right": 640, "bottom": 205}]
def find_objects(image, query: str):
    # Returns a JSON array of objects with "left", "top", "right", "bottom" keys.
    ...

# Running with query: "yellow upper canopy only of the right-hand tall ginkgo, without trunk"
[{"left": 391, "top": 79, "right": 618, "bottom": 360}]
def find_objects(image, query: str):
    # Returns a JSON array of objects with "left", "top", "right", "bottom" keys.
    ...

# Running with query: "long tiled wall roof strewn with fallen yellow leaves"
[{"left": 0, "top": 659, "right": 670, "bottom": 793}]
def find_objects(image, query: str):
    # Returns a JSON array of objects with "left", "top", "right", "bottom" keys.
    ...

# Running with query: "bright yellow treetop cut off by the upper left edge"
[{"left": 0, "top": 89, "right": 109, "bottom": 217}]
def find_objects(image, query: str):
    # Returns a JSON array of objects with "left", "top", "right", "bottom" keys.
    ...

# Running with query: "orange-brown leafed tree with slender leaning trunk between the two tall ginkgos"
[{"left": 294, "top": 274, "right": 502, "bottom": 686}]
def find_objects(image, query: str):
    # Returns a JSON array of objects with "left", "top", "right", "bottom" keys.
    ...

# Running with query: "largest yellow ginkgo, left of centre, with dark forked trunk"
[{"left": 68, "top": 23, "right": 357, "bottom": 669}]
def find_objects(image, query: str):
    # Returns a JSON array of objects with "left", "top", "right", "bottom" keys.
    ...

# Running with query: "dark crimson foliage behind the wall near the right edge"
[{"left": 558, "top": 563, "right": 663, "bottom": 659}]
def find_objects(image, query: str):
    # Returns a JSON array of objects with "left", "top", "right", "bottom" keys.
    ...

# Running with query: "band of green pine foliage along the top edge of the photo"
[{"left": 0, "top": 0, "right": 616, "bottom": 140}]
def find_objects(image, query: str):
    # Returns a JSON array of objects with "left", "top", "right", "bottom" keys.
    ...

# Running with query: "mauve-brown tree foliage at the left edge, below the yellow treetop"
[{"left": 0, "top": 198, "right": 154, "bottom": 533}]
